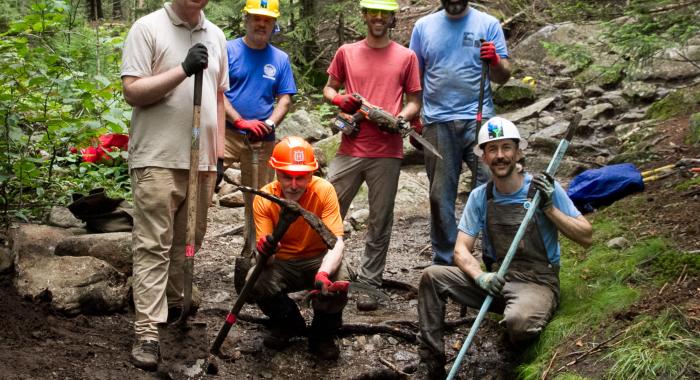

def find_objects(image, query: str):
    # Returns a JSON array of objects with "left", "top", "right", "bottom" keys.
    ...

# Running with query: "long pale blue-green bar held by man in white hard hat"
[{"left": 447, "top": 114, "right": 581, "bottom": 380}]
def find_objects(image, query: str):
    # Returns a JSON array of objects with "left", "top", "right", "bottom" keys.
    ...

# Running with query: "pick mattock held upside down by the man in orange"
[{"left": 209, "top": 186, "right": 337, "bottom": 356}]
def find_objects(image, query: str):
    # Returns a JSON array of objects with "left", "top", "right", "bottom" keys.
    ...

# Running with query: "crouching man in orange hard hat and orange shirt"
[{"left": 251, "top": 137, "right": 348, "bottom": 360}]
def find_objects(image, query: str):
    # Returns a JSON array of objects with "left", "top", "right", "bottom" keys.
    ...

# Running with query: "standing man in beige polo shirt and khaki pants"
[{"left": 121, "top": 0, "right": 228, "bottom": 370}]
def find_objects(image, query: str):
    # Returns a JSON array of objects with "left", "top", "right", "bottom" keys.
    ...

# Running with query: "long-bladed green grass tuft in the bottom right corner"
[{"left": 603, "top": 312, "right": 700, "bottom": 379}]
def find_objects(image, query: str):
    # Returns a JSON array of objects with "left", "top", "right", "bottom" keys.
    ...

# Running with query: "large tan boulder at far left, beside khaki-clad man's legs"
[{"left": 12, "top": 225, "right": 129, "bottom": 315}]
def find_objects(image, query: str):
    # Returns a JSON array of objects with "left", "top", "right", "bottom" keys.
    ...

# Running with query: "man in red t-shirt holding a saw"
[{"left": 323, "top": 0, "right": 421, "bottom": 310}]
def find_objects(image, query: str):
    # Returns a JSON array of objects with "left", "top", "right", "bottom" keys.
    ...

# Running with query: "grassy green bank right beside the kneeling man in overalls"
[{"left": 517, "top": 218, "right": 673, "bottom": 379}]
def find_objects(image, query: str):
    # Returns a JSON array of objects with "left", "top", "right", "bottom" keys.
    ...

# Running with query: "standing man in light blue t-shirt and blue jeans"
[{"left": 410, "top": 0, "right": 510, "bottom": 265}]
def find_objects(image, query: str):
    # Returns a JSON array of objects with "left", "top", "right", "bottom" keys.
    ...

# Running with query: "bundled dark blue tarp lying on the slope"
[{"left": 567, "top": 164, "right": 644, "bottom": 213}]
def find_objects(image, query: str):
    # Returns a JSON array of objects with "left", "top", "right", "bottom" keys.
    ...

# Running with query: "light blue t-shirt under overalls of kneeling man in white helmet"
[{"left": 458, "top": 174, "right": 581, "bottom": 265}]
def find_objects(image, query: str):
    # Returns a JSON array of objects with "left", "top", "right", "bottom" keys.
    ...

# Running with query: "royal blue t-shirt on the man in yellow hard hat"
[{"left": 226, "top": 38, "right": 297, "bottom": 139}]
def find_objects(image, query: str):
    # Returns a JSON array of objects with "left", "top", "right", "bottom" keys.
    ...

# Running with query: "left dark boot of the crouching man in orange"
[{"left": 258, "top": 293, "right": 306, "bottom": 350}]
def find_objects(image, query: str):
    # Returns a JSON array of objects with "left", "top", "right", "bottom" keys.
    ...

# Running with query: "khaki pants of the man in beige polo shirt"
[{"left": 130, "top": 167, "right": 216, "bottom": 339}]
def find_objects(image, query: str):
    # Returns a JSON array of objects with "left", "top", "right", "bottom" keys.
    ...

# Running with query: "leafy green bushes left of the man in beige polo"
[{"left": 0, "top": 0, "right": 131, "bottom": 226}]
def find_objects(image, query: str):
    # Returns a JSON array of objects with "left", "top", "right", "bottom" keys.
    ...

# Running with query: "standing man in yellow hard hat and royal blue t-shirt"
[{"left": 222, "top": 0, "right": 297, "bottom": 240}]
